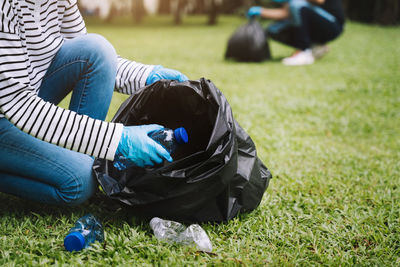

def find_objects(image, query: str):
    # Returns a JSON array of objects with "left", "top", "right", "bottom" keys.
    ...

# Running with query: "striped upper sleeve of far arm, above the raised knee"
[{"left": 61, "top": 0, "right": 87, "bottom": 39}]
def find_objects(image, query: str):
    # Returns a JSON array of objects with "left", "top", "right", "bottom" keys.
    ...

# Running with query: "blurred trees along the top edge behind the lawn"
[{"left": 78, "top": 0, "right": 400, "bottom": 25}]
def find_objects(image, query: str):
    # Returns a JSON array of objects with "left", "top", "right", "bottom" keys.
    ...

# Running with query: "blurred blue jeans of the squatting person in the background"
[{"left": 267, "top": 0, "right": 343, "bottom": 50}]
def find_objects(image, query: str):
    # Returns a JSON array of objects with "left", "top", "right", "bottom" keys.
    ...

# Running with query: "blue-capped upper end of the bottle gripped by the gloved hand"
[{"left": 149, "top": 127, "right": 189, "bottom": 154}]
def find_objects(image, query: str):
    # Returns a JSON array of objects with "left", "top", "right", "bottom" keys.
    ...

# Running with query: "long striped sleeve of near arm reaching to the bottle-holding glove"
[{"left": 0, "top": 7, "right": 123, "bottom": 160}]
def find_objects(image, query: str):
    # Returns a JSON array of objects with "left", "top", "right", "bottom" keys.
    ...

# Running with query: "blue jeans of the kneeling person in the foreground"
[{"left": 0, "top": 34, "right": 117, "bottom": 205}]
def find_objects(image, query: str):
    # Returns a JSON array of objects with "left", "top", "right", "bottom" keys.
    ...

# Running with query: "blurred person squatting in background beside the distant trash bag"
[{"left": 247, "top": 0, "right": 345, "bottom": 65}]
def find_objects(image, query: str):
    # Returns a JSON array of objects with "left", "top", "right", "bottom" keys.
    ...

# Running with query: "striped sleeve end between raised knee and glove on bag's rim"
[{"left": 115, "top": 57, "right": 154, "bottom": 95}]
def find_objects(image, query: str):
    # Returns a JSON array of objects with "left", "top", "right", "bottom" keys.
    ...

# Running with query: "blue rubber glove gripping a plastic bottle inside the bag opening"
[{"left": 114, "top": 124, "right": 172, "bottom": 170}]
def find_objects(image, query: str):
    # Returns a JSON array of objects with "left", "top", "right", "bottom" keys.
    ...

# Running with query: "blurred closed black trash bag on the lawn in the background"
[{"left": 225, "top": 19, "right": 271, "bottom": 62}]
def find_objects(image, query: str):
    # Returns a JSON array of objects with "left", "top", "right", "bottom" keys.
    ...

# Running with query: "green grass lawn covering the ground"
[{"left": 0, "top": 17, "right": 400, "bottom": 266}]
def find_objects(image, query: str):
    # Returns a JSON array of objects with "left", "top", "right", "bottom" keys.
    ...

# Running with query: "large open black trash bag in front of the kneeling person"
[{"left": 93, "top": 78, "right": 271, "bottom": 223}]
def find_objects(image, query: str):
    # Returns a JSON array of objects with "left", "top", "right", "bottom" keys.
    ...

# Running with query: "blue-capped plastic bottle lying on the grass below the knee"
[{"left": 64, "top": 214, "right": 104, "bottom": 251}]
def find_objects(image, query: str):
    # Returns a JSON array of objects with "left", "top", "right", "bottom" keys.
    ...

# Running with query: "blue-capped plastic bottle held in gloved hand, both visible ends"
[{"left": 113, "top": 127, "right": 189, "bottom": 171}]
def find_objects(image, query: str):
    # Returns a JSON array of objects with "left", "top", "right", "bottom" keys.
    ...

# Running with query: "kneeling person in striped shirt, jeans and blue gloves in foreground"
[{"left": 0, "top": 0, "right": 187, "bottom": 205}]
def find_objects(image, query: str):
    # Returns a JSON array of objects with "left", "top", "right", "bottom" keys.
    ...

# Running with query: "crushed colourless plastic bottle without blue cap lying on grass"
[{"left": 150, "top": 217, "right": 212, "bottom": 252}]
